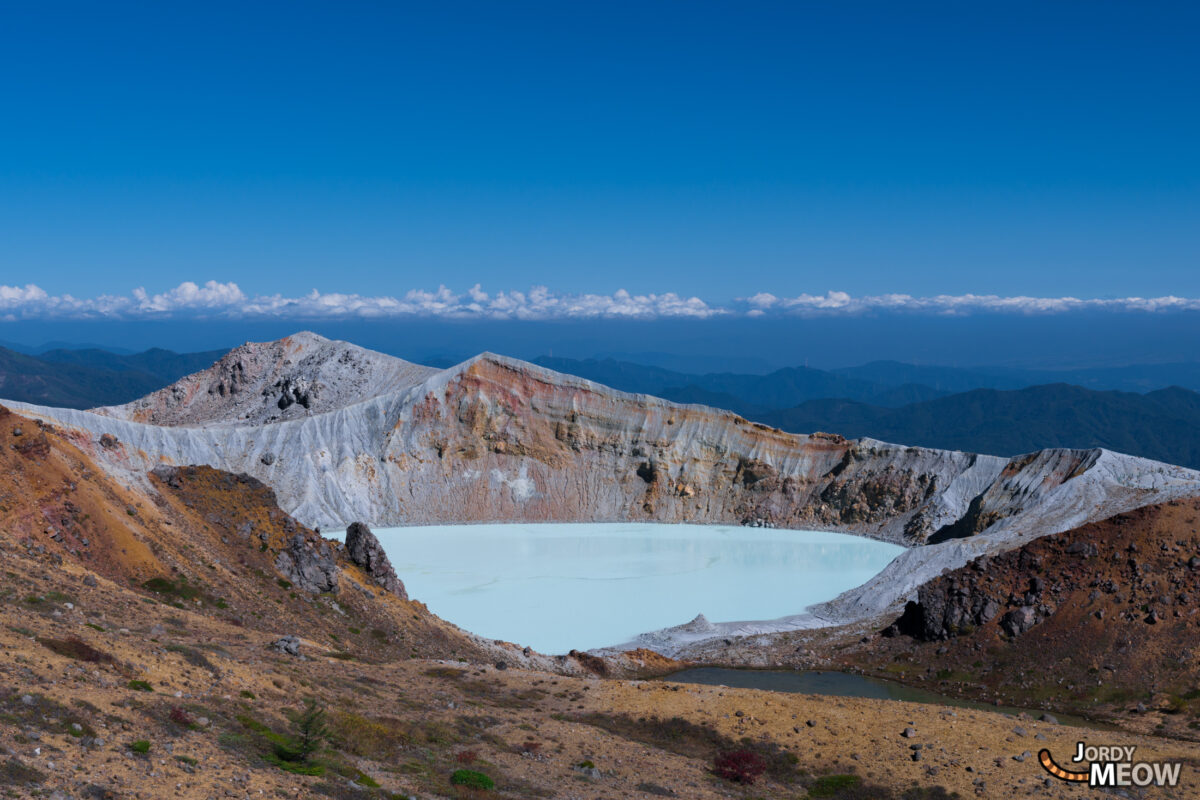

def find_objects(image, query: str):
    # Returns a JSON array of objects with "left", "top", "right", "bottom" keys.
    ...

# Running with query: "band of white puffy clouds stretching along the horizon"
[{"left": 0, "top": 281, "right": 1200, "bottom": 321}]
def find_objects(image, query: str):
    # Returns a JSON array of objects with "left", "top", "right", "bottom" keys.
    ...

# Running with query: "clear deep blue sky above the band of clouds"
[{"left": 0, "top": 0, "right": 1200, "bottom": 301}]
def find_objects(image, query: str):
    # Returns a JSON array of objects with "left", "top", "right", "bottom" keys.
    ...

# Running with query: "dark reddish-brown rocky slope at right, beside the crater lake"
[{"left": 840, "top": 500, "right": 1200, "bottom": 738}]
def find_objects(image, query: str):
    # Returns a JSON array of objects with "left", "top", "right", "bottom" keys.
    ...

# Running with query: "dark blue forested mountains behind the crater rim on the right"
[{"left": 536, "top": 357, "right": 1200, "bottom": 468}]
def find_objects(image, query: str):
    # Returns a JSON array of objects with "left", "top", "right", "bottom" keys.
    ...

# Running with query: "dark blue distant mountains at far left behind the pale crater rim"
[{"left": 0, "top": 348, "right": 224, "bottom": 408}]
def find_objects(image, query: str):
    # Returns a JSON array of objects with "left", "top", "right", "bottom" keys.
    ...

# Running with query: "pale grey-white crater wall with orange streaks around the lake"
[{"left": 6, "top": 335, "right": 1200, "bottom": 652}]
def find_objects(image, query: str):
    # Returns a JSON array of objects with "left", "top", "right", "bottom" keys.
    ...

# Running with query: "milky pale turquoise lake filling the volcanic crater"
[{"left": 348, "top": 524, "right": 904, "bottom": 654}]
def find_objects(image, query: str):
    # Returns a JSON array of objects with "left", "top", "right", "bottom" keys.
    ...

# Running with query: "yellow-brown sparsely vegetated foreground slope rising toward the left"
[{"left": 0, "top": 414, "right": 1200, "bottom": 800}]
